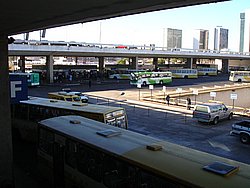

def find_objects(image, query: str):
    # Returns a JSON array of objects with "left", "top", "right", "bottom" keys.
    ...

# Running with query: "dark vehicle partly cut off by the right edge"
[{"left": 230, "top": 120, "right": 250, "bottom": 144}]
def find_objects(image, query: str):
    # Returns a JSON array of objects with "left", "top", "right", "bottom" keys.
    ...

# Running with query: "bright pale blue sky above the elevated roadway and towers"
[{"left": 12, "top": 0, "right": 250, "bottom": 51}]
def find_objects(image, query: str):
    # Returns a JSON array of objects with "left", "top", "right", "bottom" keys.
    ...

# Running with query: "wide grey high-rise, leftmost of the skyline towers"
[{"left": 163, "top": 28, "right": 182, "bottom": 48}]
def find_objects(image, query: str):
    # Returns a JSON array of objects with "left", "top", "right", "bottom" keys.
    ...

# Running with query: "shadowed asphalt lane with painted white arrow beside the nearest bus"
[{"left": 120, "top": 105, "right": 250, "bottom": 164}]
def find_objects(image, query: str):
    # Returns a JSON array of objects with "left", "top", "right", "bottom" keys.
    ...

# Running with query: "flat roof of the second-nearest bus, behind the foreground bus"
[{"left": 20, "top": 97, "right": 123, "bottom": 114}]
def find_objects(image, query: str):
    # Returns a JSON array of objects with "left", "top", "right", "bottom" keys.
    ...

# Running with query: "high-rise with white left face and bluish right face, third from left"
[{"left": 214, "top": 26, "right": 228, "bottom": 50}]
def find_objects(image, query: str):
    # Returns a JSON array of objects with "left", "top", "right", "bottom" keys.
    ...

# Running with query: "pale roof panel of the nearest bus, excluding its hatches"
[{"left": 40, "top": 116, "right": 250, "bottom": 187}]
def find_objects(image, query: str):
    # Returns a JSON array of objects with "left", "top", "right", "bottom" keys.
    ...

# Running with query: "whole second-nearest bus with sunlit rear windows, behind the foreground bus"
[{"left": 12, "top": 97, "right": 128, "bottom": 141}]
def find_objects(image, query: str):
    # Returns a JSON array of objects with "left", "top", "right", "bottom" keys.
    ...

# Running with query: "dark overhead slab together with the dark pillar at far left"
[{"left": 0, "top": 0, "right": 229, "bottom": 187}]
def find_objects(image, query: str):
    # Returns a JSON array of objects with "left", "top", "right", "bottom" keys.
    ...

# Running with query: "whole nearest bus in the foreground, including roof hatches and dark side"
[{"left": 37, "top": 116, "right": 250, "bottom": 188}]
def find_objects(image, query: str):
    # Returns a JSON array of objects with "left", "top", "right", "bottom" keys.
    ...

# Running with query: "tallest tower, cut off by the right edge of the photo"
[{"left": 239, "top": 9, "right": 250, "bottom": 52}]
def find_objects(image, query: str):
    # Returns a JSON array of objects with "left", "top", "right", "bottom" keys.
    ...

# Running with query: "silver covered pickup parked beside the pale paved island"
[{"left": 193, "top": 103, "right": 233, "bottom": 124}]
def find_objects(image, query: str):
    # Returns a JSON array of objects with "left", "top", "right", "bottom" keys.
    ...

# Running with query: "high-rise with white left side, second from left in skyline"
[{"left": 193, "top": 29, "right": 209, "bottom": 50}]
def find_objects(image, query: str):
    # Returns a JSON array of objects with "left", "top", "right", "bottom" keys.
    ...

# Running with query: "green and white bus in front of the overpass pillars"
[{"left": 130, "top": 72, "right": 172, "bottom": 86}]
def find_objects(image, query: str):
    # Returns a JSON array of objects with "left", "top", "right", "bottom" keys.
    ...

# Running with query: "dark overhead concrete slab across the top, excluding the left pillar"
[{"left": 0, "top": 0, "right": 227, "bottom": 35}]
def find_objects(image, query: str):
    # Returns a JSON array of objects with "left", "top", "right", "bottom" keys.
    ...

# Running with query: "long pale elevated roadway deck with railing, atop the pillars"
[{"left": 9, "top": 41, "right": 250, "bottom": 60}]
